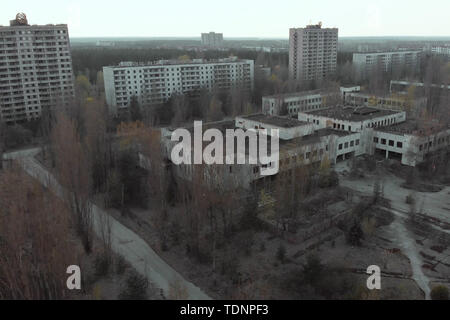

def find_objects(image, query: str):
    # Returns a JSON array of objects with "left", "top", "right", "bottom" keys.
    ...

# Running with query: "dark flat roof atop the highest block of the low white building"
[{"left": 304, "top": 106, "right": 401, "bottom": 121}]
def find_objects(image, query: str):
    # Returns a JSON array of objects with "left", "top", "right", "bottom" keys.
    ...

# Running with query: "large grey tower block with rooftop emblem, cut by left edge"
[{"left": 0, "top": 14, "right": 74, "bottom": 123}]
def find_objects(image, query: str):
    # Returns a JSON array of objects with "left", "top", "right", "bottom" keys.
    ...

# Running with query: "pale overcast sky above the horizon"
[{"left": 0, "top": 0, "right": 450, "bottom": 39}]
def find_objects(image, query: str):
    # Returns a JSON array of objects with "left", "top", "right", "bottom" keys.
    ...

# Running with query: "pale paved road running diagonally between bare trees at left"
[{"left": 4, "top": 148, "right": 211, "bottom": 300}]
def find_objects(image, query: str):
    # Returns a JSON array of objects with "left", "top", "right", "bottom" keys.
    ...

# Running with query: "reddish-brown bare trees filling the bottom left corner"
[{"left": 0, "top": 167, "right": 80, "bottom": 300}]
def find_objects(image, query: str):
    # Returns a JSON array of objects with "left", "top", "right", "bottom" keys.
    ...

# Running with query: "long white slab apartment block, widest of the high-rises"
[{"left": 103, "top": 57, "right": 254, "bottom": 112}]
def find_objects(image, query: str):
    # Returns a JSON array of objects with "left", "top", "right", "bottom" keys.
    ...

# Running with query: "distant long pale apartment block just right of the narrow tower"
[{"left": 353, "top": 51, "right": 421, "bottom": 79}]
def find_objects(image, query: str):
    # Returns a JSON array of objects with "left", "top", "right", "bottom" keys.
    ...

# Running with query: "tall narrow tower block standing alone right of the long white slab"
[{"left": 289, "top": 23, "right": 338, "bottom": 81}]
